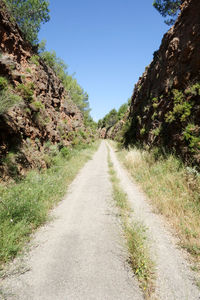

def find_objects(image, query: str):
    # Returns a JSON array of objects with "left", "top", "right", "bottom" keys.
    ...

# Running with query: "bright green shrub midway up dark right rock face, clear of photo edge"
[{"left": 165, "top": 90, "right": 193, "bottom": 123}]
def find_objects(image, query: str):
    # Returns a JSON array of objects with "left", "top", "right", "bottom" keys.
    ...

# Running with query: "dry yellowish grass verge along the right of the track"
[{"left": 119, "top": 148, "right": 200, "bottom": 262}]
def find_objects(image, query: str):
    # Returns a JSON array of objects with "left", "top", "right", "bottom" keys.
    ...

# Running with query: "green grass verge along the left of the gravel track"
[{"left": 0, "top": 142, "right": 98, "bottom": 269}]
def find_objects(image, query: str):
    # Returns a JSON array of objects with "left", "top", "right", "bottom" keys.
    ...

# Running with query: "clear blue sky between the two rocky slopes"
[{"left": 39, "top": 0, "right": 169, "bottom": 121}]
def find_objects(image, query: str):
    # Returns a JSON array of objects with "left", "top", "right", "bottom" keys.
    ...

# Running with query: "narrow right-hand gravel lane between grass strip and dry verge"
[{"left": 109, "top": 142, "right": 200, "bottom": 300}]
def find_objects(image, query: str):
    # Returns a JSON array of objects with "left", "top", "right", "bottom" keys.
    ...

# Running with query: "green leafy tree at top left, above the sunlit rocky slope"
[{"left": 4, "top": 0, "right": 50, "bottom": 44}]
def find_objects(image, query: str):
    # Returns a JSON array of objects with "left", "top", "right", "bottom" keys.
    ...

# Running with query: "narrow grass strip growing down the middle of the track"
[{"left": 108, "top": 153, "right": 154, "bottom": 299}]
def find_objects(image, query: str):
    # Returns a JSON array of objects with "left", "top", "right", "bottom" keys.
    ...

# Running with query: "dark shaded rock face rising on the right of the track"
[{"left": 125, "top": 0, "right": 200, "bottom": 164}]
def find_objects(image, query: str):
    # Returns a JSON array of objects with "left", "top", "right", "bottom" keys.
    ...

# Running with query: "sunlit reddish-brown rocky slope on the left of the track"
[{"left": 0, "top": 5, "right": 85, "bottom": 177}]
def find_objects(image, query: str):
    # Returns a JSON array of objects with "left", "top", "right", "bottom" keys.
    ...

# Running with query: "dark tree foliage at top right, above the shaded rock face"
[{"left": 153, "top": 0, "right": 184, "bottom": 25}]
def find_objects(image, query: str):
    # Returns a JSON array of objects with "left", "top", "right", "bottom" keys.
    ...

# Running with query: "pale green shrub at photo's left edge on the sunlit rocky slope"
[{"left": 0, "top": 90, "right": 22, "bottom": 115}]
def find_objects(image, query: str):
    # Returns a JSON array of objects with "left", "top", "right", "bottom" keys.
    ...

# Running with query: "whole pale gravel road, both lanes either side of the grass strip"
[{"left": 0, "top": 141, "right": 200, "bottom": 300}]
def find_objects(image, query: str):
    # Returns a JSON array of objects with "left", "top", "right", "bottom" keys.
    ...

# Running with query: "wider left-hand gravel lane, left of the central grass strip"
[{"left": 0, "top": 142, "right": 143, "bottom": 300}]
